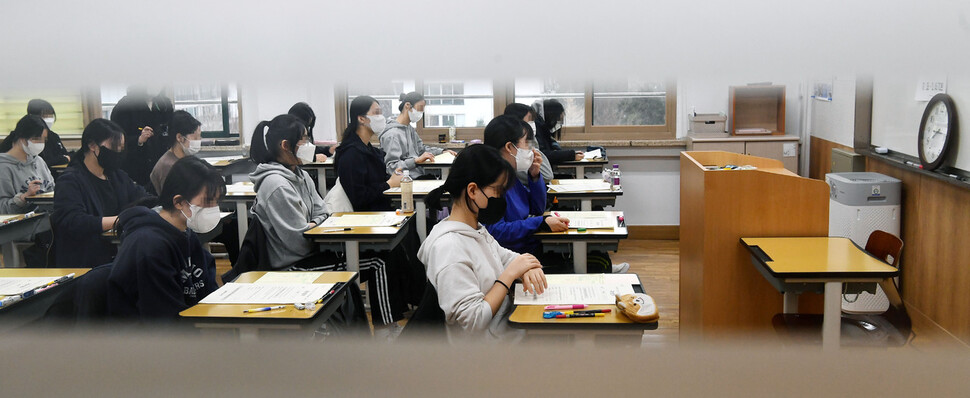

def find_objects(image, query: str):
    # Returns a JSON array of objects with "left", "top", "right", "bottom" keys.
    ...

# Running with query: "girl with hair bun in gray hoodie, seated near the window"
[{"left": 380, "top": 91, "right": 455, "bottom": 179}]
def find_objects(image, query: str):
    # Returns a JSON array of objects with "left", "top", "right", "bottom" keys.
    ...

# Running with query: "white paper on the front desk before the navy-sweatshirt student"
[{"left": 200, "top": 283, "right": 334, "bottom": 304}]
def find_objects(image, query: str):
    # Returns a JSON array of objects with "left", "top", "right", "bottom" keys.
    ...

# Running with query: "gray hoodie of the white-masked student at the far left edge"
[{"left": 0, "top": 153, "right": 54, "bottom": 214}]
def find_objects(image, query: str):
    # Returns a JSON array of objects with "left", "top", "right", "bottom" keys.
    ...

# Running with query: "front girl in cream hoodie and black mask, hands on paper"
[{"left": 418, "top": 145, "right": 547, "bottom": 341}]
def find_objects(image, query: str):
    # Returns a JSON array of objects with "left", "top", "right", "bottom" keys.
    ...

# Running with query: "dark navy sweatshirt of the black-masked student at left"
[{"left": 51, "top": 162, "right": 147, "bottom": 268}]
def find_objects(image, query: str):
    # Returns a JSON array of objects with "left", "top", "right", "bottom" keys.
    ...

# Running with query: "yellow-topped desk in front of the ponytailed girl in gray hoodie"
[{"left": 303, "top": 211, "right": 414, "bottom": 272}]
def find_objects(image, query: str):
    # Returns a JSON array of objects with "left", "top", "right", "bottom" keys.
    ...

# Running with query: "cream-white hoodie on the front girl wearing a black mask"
[{"left": 418, "top": 219, "right": 523, "bottom": 341}]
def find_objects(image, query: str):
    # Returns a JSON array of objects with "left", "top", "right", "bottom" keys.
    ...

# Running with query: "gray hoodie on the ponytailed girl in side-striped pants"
[{"left": 249, "top": 162, "right": 329, "bottom": 268}]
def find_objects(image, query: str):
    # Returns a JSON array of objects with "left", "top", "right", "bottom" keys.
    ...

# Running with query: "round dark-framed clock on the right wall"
[{"left": 919, "top": 94, "right": 957, "bottom": 170}]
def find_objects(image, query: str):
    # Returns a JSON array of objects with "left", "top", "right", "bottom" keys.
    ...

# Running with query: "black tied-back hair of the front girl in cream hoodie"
[{"left": 424, "top": 144, "right": 516, "bottom": 210}]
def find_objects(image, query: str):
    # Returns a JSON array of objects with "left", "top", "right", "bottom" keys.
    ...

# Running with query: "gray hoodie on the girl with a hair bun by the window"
[{"left": 380, "top": 119, "right": 445, "bottom": 178}]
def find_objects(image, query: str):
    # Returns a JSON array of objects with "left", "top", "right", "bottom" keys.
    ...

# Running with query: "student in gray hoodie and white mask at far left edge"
[{"left": 0, "top": 115, "right": 54, "bottom": 214}]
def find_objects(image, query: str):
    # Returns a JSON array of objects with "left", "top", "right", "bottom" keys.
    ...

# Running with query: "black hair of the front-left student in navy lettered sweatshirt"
[{"left": 158, "top": 156, "right": 226, "bottom": 211}]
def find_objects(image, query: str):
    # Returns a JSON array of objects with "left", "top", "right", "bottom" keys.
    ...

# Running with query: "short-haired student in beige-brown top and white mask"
[{"left": 150, "top": 111, "right": 202, "bottom": 192}]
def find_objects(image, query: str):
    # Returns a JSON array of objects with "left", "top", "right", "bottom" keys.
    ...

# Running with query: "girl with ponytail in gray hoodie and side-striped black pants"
[{"left": 249, "top": 115, "right": 406, "bottom": 328}]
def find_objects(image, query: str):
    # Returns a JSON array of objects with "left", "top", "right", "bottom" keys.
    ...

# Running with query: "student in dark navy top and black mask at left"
[{"left": 51, "top": 119, "right": 147, "bottom": 268}]
